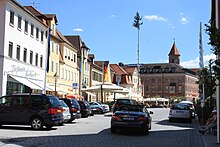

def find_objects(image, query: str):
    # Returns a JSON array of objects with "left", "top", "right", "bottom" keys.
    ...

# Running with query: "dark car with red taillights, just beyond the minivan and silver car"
[{"left": 59, "top": 98, "right": 81, "bottom": 122}]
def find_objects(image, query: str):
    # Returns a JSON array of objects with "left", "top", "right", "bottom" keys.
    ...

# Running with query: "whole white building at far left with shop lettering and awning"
[{"left": 0, "top": 0, "right": 47, "bottom": 95}]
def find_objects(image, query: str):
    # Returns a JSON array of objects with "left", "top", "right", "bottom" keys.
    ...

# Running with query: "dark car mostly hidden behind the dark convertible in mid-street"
[{"left": 112, "top": 98, "right": 137, "bottom": 113}]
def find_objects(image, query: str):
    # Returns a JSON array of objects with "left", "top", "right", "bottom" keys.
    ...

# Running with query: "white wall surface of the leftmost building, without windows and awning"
[{"left": 0, "top": 1, "right": 47, "bottom": 95}]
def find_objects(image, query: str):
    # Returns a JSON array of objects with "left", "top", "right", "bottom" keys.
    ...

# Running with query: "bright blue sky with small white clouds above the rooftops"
[{"left": 17, "top": 0, "right": 215, "bottom": 68}]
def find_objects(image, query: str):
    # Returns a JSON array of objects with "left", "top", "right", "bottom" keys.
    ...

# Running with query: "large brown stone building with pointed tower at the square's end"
[{"left": 140, "top": 42, "right": 199, "bottom": 100}]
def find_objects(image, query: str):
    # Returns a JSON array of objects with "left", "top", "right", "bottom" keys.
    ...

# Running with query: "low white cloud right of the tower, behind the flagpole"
[{"left": 180, "top": 54, "right": 216, "bottom": 68}]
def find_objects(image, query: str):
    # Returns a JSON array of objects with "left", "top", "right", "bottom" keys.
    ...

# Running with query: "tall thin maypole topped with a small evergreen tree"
[{"left": 133, "top": 12, "right": 143, "bottom": 94}]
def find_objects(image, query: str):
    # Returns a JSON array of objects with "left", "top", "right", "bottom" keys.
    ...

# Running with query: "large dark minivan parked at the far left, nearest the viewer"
[{"left": 0, "top": 93, "right": 63, "bottom": 130}]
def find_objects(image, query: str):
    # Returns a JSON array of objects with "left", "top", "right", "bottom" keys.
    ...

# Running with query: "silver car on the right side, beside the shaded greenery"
[{"left": 168, "top": 103, "right": 192, "bottom": 122}]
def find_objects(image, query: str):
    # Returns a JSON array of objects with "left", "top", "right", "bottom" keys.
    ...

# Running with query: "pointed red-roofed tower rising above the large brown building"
[{"left": 168, "top": 41, "right": 180, "bottom": 64}]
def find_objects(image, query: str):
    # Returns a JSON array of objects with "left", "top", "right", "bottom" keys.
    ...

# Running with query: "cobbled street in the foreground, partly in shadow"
[{"left": 0, "top": 108, "right": 203, "bottom": 147}]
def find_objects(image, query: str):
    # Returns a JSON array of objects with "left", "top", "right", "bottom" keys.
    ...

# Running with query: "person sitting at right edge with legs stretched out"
[{"left": 199, "top": 110, "right": 217, "bottom": 135}]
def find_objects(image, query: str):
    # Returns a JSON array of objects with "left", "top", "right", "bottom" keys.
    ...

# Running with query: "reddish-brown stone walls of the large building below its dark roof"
[{"left": 141, "top": 73, "right": 198, "bottom": 99}]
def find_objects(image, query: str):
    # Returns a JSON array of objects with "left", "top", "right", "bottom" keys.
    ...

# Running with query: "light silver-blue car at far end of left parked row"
[{"left": 89, "top": 102, "right": 109, "bottom": 114}]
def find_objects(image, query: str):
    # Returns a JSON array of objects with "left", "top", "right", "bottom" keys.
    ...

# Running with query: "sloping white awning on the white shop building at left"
[{"left": 10, "top": 75, "right": 43, "bottom": 90}]
